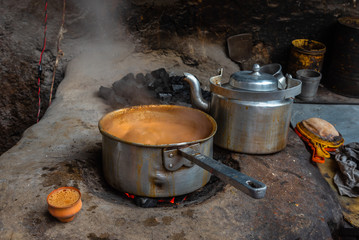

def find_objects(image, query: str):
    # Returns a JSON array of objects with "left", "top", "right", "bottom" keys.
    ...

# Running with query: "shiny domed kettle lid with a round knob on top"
[{"left": 229, "top": 64, "right": 278, "bottom": 92}]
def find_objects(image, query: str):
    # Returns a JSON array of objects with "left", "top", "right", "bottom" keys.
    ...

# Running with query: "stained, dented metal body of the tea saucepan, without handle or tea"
[{"left": 99, "top": 105, "right": 216, "bottom": 197}]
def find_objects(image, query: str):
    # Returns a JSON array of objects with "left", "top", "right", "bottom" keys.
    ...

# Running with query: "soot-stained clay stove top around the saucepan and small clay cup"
[{"left": 0, "top": 40, "right": 342, "bottom": 240}]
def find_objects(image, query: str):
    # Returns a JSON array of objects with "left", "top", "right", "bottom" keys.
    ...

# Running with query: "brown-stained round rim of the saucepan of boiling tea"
[{"left": 98, "top": 104, "right": 217, "bottom": 148}]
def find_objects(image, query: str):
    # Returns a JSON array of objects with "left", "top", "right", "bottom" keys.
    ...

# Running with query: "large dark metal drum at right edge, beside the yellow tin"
[{"left": 325, "top": 17, "right": 359, "bottom": 98}]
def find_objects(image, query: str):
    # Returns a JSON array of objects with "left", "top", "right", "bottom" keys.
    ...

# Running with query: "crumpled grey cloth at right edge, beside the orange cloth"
[{"left": 334, "top": 142, "right": 359, "bottom": 197}]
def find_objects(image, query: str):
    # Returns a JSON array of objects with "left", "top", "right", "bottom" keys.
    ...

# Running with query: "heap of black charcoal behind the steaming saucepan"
[{"left": 99, "top": 68, "right": 211, "bottom": 109}]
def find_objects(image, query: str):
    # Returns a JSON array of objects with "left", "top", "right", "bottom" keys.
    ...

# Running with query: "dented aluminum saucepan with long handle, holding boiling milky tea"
[{"left": 99, "top": 105, "right": 266, "bottom": 198}]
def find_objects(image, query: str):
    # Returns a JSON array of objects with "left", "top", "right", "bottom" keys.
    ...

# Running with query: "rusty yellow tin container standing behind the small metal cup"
[{"left": 287, "top": 39, "right": 326, "bottom": 76}]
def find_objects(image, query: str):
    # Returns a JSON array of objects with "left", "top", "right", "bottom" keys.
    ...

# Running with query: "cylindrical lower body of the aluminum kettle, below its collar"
[{"left": 211, "top": 94, "right": 293, "bottom": 154}]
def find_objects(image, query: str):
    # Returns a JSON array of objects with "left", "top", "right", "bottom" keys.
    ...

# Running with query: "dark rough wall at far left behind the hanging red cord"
[{"left": 0, "top": 0, "right": 95, "bottom": 154}]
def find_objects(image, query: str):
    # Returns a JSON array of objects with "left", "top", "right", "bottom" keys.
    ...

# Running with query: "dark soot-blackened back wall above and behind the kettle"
[{"left": 121, "top": 0, "right": 358, "bottom": 69}]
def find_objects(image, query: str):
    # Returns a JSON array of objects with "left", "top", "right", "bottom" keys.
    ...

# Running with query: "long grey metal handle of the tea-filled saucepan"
[{"left": 178, "top": 147, "right": 267, "bottom": 199}]
